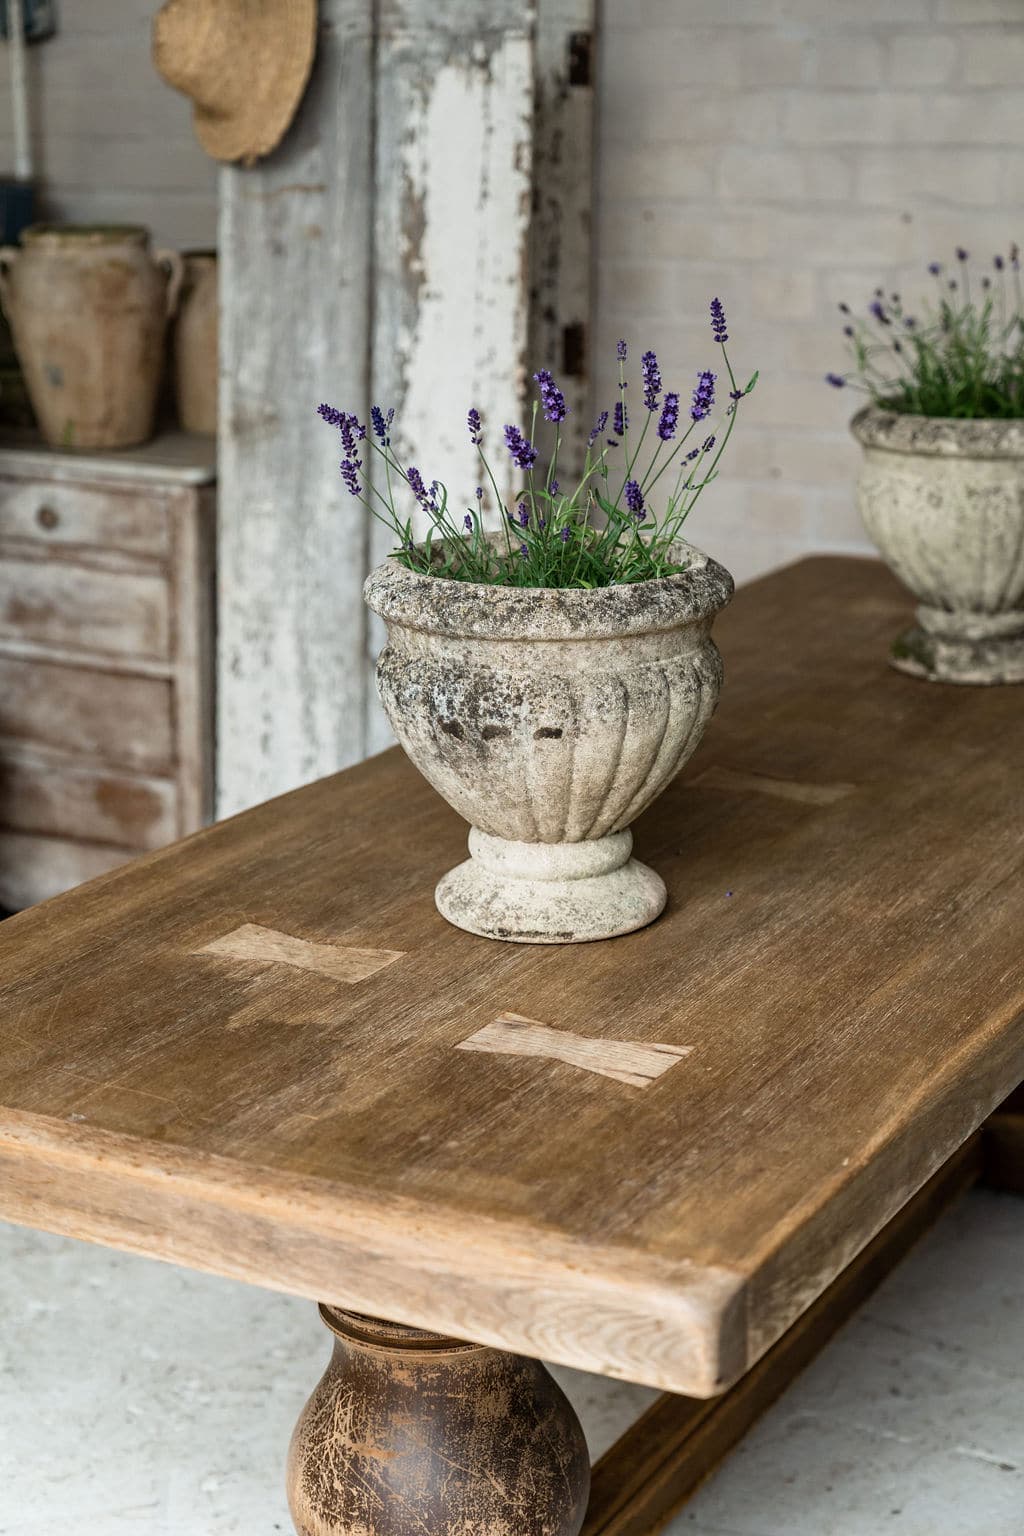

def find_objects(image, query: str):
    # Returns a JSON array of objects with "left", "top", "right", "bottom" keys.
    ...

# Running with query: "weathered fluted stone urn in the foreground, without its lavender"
[{"left": 364, "top": 544, "right": 732, "bottom": 943}]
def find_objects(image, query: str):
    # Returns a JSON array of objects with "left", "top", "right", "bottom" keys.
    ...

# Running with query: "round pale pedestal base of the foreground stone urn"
[{"left": 434, "top": 828, "right": 668, "bottom": 945}]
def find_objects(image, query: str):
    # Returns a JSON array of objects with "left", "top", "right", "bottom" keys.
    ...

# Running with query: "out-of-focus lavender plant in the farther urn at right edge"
[{"left": 826, "top": 244, "right": 1024, "bottom": 419}]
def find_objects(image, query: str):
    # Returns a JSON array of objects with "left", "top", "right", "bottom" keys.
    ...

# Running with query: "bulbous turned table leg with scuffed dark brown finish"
[{"left": 287, "top": 1306, "right": 590, "bottom": 1536}]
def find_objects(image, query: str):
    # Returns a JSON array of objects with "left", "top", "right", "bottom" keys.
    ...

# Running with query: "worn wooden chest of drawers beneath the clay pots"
[{"left": 0, "top": 435, "right": 215, "bottom": 909}]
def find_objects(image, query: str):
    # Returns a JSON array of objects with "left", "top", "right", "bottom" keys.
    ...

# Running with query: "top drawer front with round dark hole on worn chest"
[{"left": 0, "top": 479, "right": 170, "bottom": 558}]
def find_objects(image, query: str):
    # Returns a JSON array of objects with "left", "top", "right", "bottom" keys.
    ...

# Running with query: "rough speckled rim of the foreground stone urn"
[{"left": 362, "top": 541, "right": 734, "bottom": 641}]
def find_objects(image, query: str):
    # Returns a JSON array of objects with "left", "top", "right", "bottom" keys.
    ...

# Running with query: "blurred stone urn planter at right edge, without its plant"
[{"left": 851, "top": 406, "right": 1024, "bottom": 684}]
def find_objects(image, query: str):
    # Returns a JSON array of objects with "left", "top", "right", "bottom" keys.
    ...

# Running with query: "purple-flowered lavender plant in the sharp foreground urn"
[{"left": 319, "top": 298, "right": 757, "bottom": 588}]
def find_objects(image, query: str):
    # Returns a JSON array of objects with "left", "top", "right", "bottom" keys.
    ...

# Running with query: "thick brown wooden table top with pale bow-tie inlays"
[{"left": 0, "top": 558, "right": 1024, "bottom": 1396}]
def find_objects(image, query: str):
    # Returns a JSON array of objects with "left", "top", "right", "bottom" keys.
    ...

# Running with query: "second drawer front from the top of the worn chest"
[{"left": 0, "top": 556, "right": 170, "bottom": 660}]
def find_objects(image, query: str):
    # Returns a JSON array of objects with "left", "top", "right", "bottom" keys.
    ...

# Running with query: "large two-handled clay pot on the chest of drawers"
[{"left": 0, "top": 224, "right": 181, "bottom": 449}]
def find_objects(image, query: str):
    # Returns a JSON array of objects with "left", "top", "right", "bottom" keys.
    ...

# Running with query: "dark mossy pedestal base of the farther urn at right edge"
[{"left": 889, "top": 607, "right": 1024, "bottom": 687}]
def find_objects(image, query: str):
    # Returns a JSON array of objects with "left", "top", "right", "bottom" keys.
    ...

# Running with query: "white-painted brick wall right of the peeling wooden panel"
[{"left": 594, "top": 0, "right": 1024, "bottom": 579}]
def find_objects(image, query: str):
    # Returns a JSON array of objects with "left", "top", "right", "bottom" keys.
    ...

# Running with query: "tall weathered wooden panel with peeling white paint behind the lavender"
[{"left": 218, "top": 0, "right": 593, "bottom": 814}]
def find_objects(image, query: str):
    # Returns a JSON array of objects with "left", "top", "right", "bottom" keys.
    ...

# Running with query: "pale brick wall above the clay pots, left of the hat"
[{"left": 0, "top": 0, "right": 216, "bottom": 249}]
